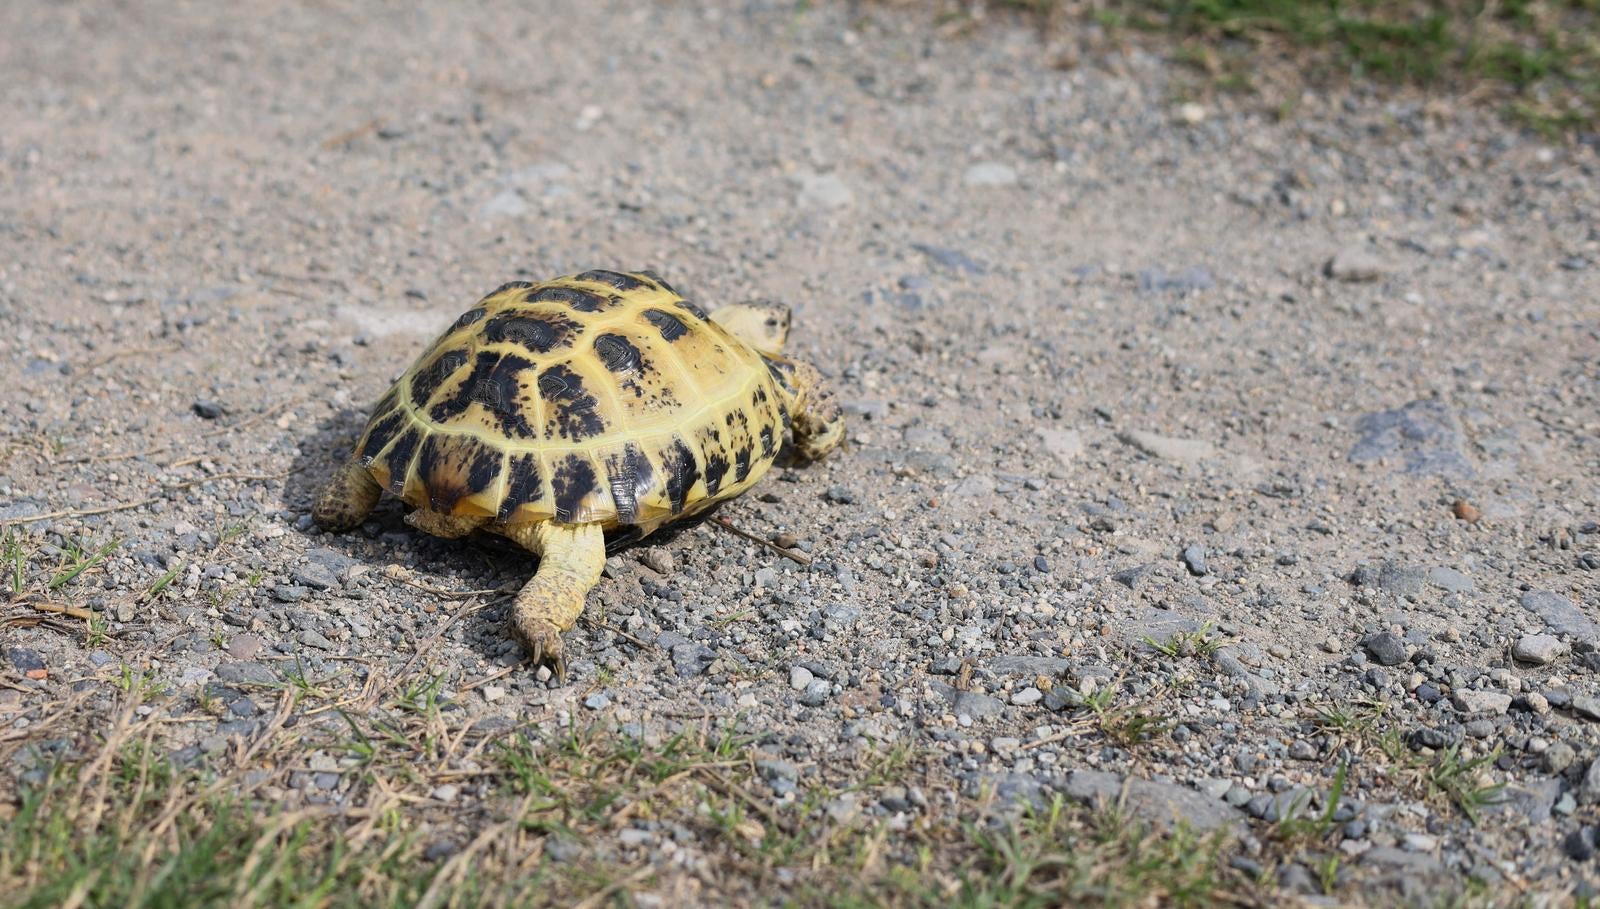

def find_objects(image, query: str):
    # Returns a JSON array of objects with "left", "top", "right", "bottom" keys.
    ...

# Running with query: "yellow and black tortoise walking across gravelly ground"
[{"left": 312, "top": 270, "right": 845, "bottom": 680}]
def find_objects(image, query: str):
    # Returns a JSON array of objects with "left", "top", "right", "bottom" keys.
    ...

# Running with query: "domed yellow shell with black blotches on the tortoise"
[{"left": 357, "top": 270, "right": 789, "bottom": 531}]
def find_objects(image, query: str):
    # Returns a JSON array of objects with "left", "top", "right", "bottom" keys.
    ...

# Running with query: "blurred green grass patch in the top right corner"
[{"left": 889, "top": 0, "right": 1600, "bottom": 136}]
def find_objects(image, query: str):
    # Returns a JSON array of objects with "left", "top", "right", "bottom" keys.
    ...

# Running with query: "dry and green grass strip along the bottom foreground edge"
[{"left": 0, "top": 667, "right": 1269, "bottom": 909}]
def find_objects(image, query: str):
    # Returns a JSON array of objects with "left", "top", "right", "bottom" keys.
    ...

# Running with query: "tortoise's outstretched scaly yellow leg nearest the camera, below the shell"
[{"left": 501, "top": 522, "right": 605, "bottom": 682}]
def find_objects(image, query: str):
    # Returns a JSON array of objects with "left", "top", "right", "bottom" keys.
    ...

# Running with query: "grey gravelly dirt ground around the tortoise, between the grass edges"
[{"left": 0, "top": 0, "right": 1600, "bottom": 904}]
